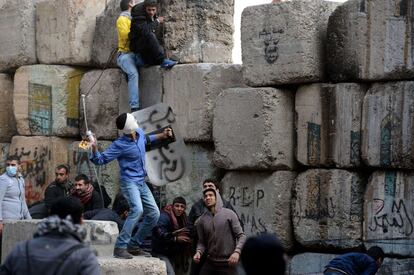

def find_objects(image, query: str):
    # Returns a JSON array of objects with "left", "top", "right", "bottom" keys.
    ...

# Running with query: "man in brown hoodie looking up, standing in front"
[{"left": 194, "top": 189, "right": 246, "bottom": 275}]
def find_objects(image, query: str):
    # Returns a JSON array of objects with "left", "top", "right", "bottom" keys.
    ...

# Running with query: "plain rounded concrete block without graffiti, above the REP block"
[{"left": 213, "top": 88, "right": 294, "bottom": 170}]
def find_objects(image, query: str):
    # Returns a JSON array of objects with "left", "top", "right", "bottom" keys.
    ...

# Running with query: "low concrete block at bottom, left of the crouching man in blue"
[{"left": 288, "top": 252, "right": 338, "bottom": 275}]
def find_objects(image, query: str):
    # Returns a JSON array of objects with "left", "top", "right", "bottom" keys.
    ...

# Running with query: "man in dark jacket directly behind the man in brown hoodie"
[{"left": 188, "top": 179, "right": 243, "bottom": 275}]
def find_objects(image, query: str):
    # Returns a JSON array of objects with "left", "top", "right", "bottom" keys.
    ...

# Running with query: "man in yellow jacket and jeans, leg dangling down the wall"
[{"left": 116, "top": 0, "right": 176, "bottom": 113}]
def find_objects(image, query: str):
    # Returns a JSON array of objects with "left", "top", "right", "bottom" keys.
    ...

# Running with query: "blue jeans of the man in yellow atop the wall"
[{"left": 116, "top": 52, "right": 144, "bottom": 108}]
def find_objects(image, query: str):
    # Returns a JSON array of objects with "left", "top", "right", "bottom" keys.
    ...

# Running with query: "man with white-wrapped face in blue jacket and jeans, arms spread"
[{"left": 91, "top": 113, "right": 173, "bottom": 259}]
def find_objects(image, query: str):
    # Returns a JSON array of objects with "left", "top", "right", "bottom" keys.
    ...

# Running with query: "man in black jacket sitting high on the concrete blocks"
[{"left": 129, "top": 0, "right": 177, "bottom": 69}]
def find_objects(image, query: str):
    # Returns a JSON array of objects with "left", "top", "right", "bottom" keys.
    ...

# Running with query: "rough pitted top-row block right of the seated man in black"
[{"left": 160, "top": 0, "right": 234, "bottom": 63}]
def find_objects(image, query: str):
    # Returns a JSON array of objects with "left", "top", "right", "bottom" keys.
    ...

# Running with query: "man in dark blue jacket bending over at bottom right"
[{"left": 323, "top": 246, "right": 385, "bottom": 275}]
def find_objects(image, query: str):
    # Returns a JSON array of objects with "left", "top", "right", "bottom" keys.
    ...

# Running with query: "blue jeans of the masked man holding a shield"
[{"left": 115, "top": 182, "right": 160, "bottom": 248}]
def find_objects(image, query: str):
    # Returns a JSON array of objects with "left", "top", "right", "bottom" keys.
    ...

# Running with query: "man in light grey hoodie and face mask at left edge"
[{"left": 0, "top": 156, "right": 32, "bottom": 234}]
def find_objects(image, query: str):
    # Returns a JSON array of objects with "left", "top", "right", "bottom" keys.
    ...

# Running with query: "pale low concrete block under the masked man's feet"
[{"left": 98, "top": 257, "right": 167, "bottom": 275}]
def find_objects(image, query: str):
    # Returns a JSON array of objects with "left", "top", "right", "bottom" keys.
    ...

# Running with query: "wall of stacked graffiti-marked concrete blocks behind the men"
[{"left": 0, "top": 0, "right": 414, "bottom": 274}]
